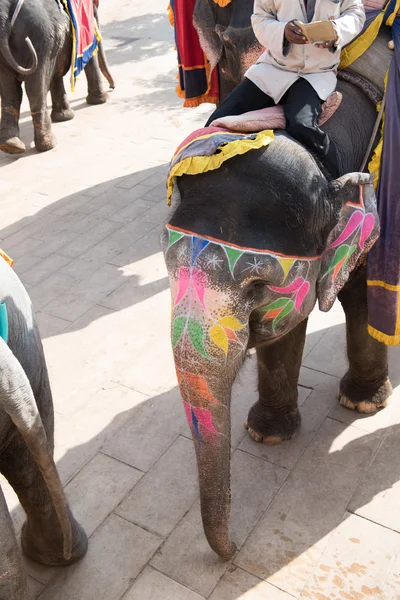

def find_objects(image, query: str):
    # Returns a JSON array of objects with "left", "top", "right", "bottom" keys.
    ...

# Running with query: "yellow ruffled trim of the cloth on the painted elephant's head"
[{"left": 167, "top": 129, "right": 274, "bottom": 205}]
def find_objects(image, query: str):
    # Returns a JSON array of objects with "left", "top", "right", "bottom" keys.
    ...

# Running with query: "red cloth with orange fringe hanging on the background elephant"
[{"left": 168, "top": 0, "right": 223, "bottom": 108}]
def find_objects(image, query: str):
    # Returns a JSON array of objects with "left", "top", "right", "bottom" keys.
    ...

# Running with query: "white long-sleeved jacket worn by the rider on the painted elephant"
[{"left": 245, "top": 0, "right": 365, "bottom": 103}]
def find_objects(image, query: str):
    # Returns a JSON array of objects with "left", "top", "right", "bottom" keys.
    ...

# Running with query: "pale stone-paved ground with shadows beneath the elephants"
[{"left": 0, "top": 0, "right": 400, "bottom": 600}]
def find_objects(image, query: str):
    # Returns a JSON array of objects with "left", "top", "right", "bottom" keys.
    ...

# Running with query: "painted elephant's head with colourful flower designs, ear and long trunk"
[{"left": 163, "top": 141, "right": 378, "bottom": 558}]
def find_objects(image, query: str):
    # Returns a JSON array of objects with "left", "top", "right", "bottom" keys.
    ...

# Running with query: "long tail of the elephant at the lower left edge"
[{"left": 0, "top": 338, "right": 72, "bottom": 560}]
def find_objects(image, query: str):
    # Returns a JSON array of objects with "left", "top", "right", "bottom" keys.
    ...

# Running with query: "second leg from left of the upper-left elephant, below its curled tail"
[{"left": 25, "top": 69, "right": 56, "bottom": 152}]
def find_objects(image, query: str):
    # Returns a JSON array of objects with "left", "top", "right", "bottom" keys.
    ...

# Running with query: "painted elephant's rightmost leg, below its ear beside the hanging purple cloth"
[{"left": 338, "top": 267, "right": 392, "bottom": 413}]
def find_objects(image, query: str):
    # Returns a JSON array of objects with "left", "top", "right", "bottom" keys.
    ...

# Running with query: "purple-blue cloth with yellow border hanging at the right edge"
[{"left": 341, "top": 0, "right": 400, "bottom": 346}]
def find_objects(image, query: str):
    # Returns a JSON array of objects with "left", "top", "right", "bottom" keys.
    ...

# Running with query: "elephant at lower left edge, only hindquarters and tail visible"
[{"left": 0, "top": 258, "right": 87, "bottom": 600}]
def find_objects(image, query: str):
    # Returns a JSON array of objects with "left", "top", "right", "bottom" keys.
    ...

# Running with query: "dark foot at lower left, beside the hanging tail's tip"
[{"left": 21, "top": 519, "right": 88, "bottom": 567}]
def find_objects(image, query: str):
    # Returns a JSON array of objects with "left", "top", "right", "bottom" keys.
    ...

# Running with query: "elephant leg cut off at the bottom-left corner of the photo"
[{"left": 0, "top": 486, "right": 31, "bottom": 600}]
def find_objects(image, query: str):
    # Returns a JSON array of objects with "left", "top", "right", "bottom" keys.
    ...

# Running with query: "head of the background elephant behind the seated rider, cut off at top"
[{"left": 193, "top": 0, "right": 262, "bottom": 97}]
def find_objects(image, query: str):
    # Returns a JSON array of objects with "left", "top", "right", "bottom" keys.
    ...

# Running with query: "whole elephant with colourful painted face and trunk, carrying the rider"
[{"left": 162, "top": 35, "right": 392, "bottom": 559}]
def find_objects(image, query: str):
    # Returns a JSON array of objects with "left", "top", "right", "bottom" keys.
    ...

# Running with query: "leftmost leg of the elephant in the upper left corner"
[{"left": 0, "top": 72, "right": 26, "bottom": 154}]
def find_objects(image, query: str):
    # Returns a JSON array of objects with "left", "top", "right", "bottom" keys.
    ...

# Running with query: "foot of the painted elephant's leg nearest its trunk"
[{"left": 244, "top": 402, "right": 301, "bottom": 446}]
